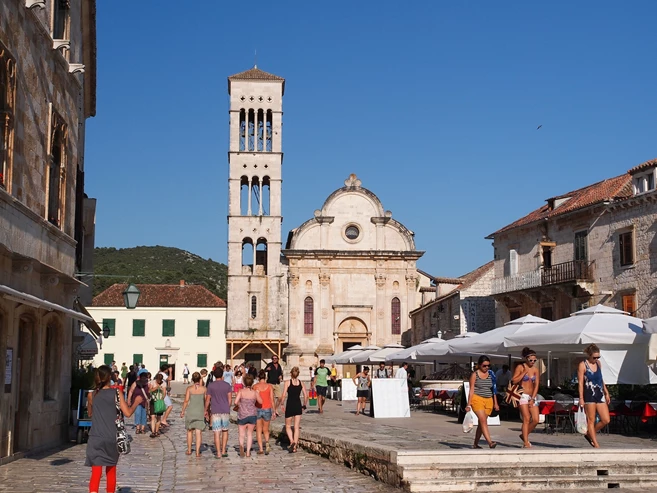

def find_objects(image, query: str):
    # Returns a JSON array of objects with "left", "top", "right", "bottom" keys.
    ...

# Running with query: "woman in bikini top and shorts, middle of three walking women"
[{"left": 511, "top": 347, "right": 540, "bottom": 448}]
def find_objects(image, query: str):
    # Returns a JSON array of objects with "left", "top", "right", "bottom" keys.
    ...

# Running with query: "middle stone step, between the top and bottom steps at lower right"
[{"left": 402, "top": 457, "right": 657, "bottom": 482}]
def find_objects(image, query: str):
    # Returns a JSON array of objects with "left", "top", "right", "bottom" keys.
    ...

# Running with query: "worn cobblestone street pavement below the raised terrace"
[{"left": 0, "top": 414, "right": 399, "bottom": 493}]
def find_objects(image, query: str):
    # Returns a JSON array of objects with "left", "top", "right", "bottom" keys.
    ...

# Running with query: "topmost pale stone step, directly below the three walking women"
[{"left": 391, "top": 448, "right": 657, "bottom": 467}]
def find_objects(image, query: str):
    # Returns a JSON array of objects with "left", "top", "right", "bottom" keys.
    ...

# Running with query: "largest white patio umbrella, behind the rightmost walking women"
[{"left": 504, "top": 305, "right": 657, "bottom": 385}]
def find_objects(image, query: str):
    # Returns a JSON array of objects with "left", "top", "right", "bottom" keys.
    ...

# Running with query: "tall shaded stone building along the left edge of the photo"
[{"left": 0, "top": 0, "right": 96, "bottom": 461}]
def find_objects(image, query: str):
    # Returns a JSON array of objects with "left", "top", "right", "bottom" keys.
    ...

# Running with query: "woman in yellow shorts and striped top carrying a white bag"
[{"left": 465, "top": 355, "right": 500, "bottom": 448}]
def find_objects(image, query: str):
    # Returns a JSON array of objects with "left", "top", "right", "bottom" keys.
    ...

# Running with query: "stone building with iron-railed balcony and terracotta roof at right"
[{"left": 488, "top": 160, "right": 657, "bottom": 325}]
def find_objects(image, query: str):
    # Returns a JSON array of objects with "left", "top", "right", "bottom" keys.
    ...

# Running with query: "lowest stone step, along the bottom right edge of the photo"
[{"left": 405, "top": 475, "right": 657, "bottom": 493}]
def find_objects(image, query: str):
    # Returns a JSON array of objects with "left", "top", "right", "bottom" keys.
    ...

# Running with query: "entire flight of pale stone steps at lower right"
[{"left": 391, "top": 449, "right": 657, "bottom": 492}]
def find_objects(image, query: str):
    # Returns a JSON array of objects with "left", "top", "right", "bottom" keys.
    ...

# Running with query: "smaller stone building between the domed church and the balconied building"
[{"left": 402, "top": 261, "right": 495, "bottom": 346}]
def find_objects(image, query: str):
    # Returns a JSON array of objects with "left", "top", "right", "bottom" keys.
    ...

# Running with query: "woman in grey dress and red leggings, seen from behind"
[{"left": 85, "top": 365, "right": 143, "bottom": 493}]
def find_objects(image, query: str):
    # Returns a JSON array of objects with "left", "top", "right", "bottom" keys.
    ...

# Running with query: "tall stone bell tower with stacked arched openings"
[{"left": 226, "top": 66, "right": 287, "bottom": 366}]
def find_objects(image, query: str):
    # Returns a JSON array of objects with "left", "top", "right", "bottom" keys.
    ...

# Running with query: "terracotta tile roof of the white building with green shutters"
[{"left": 92, "top": 284, "right": 226, "bottom": 308}]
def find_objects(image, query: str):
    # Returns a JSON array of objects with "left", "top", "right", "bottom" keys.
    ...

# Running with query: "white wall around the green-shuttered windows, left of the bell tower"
[{"left": 88, "top": 307, "right": 226, "bottom": 380}]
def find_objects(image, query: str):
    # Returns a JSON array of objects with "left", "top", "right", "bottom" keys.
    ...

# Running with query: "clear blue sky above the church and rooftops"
[{"left": 85, "top": 0, "right": 657, "bottom": 276}]
